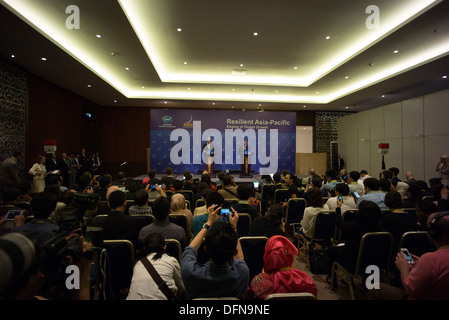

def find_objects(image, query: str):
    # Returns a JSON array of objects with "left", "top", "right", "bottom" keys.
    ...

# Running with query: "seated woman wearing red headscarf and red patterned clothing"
[{"left": 246, "top": 236, "right": 317, "bottom": 300}]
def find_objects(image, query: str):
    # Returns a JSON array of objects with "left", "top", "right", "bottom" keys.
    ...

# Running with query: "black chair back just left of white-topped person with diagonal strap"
[{"left": 101, "top": 240, "right": 135, "bottom": 300}]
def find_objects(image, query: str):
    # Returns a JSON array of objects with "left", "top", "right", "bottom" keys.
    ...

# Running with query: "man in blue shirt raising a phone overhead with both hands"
[{"left": 181, "top": 200, "right": 250, "bottom": 299}]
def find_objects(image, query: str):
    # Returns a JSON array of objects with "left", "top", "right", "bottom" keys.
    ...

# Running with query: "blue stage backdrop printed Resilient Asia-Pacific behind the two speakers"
[{"left": 150, "top": 109, "right": 296, "bottom": 174}]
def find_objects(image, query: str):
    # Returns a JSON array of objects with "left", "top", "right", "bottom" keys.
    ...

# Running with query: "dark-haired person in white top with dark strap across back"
[{"left": 126, "top": 233, "right": 184, "bottom": 300}]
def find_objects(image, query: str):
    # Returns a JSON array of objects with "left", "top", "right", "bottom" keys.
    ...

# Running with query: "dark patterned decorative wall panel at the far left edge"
[{"left": 0, "top": 59, "right": 28, "bottom": 177}]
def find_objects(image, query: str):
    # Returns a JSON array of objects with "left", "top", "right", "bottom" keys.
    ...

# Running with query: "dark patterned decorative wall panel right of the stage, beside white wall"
[{"left": 313, "top": 112, "right": 352, "bottom": 169}]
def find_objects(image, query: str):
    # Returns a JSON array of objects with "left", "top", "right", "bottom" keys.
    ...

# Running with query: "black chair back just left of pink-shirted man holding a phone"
[{"left": 354, "top": 232, "right": 393, "bottom": 275}]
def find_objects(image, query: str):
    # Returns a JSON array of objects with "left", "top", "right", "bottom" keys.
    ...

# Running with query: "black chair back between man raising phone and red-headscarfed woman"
[{"left": 239, "top": 236, "right": 268, "bottom": 279}]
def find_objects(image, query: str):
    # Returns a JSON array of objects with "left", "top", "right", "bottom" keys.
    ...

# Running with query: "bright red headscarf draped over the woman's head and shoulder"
[{"left": 263, "top": 236, "right": 317, "bottom": 295}]
